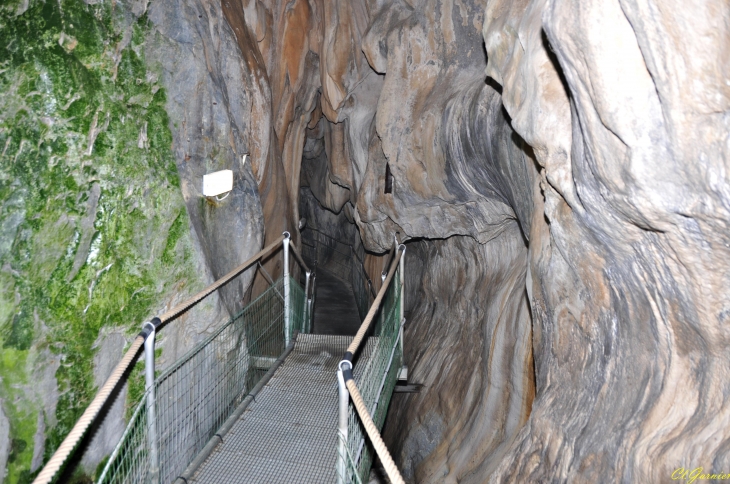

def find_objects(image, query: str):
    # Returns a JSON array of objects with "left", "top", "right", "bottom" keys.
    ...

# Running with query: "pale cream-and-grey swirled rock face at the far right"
[{"left": 484, "top": 1, "right": 730, "bottom": 482}]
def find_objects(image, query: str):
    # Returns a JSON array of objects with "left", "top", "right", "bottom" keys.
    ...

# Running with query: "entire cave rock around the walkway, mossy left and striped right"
[{"left": 0, "top": 0, "right": 730, "bottom": 483}]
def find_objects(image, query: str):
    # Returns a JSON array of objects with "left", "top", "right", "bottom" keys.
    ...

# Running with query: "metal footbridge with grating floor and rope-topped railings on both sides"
[{"left": 34, "top": 228, "right": 405, "bottom": 484}]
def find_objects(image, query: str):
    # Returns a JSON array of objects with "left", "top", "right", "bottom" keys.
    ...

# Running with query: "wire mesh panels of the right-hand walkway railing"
[{"left": 343, "top": 262, "right": 403, "bottom": 483}]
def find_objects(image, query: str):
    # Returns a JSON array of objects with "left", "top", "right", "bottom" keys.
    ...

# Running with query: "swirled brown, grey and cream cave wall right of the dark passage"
[{"left": 247, "top": 0, "right": 730, "bottom": 482}]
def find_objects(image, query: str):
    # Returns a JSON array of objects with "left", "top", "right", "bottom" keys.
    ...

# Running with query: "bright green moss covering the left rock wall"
[{"left": 0, "top": 0, "right": 202, "bottom": 483}]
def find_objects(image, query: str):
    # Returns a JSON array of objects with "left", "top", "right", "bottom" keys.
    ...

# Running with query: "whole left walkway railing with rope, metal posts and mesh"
[{"left": 34, "top": 232, "right": 313, "bottom": 484}]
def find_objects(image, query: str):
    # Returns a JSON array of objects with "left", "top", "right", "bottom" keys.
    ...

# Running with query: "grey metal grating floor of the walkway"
[{"left": 191, "top": 334, "right": 376, "bottom": 484}]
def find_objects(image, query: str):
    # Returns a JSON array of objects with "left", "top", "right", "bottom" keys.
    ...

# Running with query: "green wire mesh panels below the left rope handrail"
[{"left": 97, "top": 278, "right": 308, "bottom": 483}]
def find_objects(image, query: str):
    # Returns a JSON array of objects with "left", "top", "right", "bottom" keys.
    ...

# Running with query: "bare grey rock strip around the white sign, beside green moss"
[{"left": 146, "top": 2, "right": 264, "bottom": 314}]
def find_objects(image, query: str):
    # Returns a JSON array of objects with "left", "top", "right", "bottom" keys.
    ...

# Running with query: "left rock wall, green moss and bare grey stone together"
[{"left": 0, "top": 0, "right": 262, "bottom": 483}]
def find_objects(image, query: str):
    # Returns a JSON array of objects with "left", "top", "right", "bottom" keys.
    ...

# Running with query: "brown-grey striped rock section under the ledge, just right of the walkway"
[{"left": 385, "top": 233, "right": 535, "bottom": 482}]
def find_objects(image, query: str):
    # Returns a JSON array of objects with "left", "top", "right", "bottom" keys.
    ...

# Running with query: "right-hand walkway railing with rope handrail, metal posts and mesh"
[{"left": 337, "top": 245, "right": 405, "bottom": 484}]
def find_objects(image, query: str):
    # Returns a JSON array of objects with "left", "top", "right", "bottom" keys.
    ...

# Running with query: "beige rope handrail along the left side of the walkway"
[{"left": 33, "top": 235, "right": 285, "bottom": 484}]
